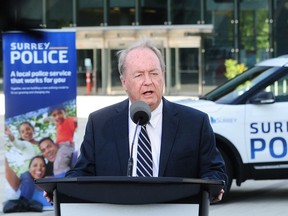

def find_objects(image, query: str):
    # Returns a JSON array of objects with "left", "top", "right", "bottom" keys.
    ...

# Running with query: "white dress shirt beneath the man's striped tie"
[{"left": 128, "top": 100, "right": 163, "bottom": 177}]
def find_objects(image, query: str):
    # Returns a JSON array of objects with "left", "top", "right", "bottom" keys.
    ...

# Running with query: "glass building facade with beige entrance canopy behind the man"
[{"left": 1, "top": 0, "right": 288, "bottom": 95}]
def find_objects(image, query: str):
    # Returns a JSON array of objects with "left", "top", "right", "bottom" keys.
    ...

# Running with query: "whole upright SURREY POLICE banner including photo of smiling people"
[{"left": 3, "top": 30, "right": 77, "bottom": 212}]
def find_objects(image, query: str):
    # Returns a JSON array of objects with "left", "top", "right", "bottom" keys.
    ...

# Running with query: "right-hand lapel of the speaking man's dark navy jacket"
[{"left": 159, "top": 99, "right": 178, "bottom": 176}]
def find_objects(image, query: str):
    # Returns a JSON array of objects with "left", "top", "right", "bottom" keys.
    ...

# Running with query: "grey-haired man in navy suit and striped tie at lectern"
[{"left": 59, "top": 40, "right": 227, "bottom": 202}]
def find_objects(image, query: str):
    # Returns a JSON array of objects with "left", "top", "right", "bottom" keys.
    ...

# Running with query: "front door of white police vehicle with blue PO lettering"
[{"left": 245, "top": 73, "right": 288, "bottom": 163}]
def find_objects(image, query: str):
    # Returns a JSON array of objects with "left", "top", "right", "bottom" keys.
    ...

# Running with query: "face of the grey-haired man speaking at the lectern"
[{"left": 121, "top": 48, "right": 164, "bottom": 111}]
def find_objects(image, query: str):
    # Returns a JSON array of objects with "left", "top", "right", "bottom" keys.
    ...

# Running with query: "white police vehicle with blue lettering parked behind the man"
[{"left": 179, "top": 55, "right": 288, "bottom": 192}]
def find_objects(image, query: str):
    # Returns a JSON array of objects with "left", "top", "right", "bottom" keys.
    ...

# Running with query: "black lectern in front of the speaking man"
[{"left": 35, "top": 176, "right": 224, "bottom": 216}]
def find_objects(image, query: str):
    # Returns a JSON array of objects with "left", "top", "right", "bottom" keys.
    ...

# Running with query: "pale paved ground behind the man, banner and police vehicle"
[{"left": 0, "top": 95, "right": 288, "bottom": 216}]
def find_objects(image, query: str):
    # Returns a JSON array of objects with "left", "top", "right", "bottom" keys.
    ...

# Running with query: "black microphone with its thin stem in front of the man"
[{"left": 127, "top": 100, "right": 151, "bottom": 176}]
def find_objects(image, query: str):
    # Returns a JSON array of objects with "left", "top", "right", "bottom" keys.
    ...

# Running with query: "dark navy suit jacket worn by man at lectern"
[{"left": 66, "top": 98, "right": 226, "bottom": 184}]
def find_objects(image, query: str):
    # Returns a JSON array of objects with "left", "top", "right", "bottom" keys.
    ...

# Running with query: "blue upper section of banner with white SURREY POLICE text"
[{"left": 3, "top": 31, "right": 76, "bottom": 118}]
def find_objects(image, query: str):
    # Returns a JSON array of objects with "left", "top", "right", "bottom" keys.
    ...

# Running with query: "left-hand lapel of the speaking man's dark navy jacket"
[{"left": 111, "top": 99, "right": 129, "bottom": 175}]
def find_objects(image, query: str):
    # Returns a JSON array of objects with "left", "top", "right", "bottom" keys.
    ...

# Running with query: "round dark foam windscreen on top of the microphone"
[{"left": 130, "top": 100, "right": 151, "bottom": 125}]
